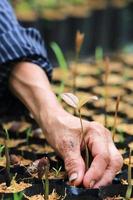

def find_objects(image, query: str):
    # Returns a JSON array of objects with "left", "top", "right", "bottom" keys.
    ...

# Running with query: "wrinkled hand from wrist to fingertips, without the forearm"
[{"left": 43, "top": 110, "right": 123, "bottom": 188}]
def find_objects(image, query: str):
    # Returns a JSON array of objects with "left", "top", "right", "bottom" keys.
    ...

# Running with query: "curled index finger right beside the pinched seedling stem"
[{"left": 83, "top": 124, "right": 110, "bottom": 187}]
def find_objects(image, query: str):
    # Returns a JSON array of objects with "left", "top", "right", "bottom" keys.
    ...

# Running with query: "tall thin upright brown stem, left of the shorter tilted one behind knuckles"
[{"left": 104, "top": 57, "right": 109, "bottom": 127}]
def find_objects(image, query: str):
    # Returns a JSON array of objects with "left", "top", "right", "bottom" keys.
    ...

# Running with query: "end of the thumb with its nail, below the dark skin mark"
[{"left": 64, "top": 149, "right": 85, "bottom": 186}]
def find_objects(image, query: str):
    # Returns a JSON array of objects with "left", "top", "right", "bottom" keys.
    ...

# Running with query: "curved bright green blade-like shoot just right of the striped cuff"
[{"left": 51, "top": 42, "right": 68, "bottom": 100}]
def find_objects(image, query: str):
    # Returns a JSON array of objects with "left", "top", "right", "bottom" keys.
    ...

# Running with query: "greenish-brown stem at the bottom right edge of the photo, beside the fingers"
[{"left": 125, "top": 148, "right": 133, "bottom": 200}]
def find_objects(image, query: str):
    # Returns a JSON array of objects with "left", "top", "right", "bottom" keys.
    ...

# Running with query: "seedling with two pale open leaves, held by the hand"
[{"left": 61, "top": 93, "right": 98, "bottom": 170}]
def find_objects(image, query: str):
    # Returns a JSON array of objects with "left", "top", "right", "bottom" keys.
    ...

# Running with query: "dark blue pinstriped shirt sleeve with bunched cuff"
[{"left": 0, "top": 0, "right": 52, "bottom": 119}]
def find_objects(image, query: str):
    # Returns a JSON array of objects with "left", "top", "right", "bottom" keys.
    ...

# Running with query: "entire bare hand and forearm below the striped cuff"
[{"left": 9, "top": 62, "right": 123, "bottom": 188}]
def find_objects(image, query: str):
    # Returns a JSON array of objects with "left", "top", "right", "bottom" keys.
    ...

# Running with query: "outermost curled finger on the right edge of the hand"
[{"left": 94, "top": 143, "right": 123, "bottom": 188}]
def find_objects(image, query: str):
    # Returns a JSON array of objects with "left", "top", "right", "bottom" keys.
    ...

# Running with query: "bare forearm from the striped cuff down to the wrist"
[{"left": 9, "top": 62, "right": 62, "bottom": 129}]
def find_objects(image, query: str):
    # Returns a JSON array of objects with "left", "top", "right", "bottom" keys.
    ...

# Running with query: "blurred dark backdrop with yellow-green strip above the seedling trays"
[{"left": 11, "top": 0, "right": 133, "bottom": 57}]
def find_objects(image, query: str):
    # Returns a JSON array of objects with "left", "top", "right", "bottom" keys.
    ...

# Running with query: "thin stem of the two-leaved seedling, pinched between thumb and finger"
[{"left": 78, "top": 109, "right": 89, "bottom": 170}]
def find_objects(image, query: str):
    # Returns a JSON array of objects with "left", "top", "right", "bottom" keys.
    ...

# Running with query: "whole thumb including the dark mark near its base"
[{"left": 58, "top": 136, "right": 85, "bottom": 186}]
